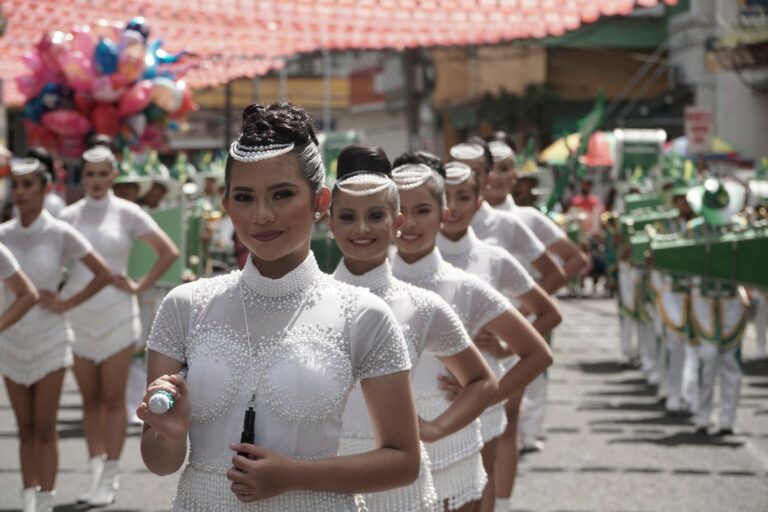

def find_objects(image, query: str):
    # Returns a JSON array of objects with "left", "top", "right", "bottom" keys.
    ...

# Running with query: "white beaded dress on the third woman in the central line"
[{"left": 392, "top": 248, "right": 512, "bottom": 509}]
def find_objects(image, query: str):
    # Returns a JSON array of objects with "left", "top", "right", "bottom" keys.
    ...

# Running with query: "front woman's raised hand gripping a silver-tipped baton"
[{"left": 136, "top": 374, "right": 192, "bottom": 442}]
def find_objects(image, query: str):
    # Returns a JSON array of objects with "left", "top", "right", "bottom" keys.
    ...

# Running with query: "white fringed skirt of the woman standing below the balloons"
[{"left": 70, "top": 286, "right": 141, "bottom": 364}]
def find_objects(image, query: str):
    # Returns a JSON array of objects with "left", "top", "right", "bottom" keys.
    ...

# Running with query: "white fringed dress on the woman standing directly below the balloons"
[{"left": 61, "top": 190, "right": 160, "bottom": 364}]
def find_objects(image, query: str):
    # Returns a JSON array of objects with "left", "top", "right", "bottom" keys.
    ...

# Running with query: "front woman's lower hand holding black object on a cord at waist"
[{"left": 227, "top": 443, "right": 294, "bottom": 503}]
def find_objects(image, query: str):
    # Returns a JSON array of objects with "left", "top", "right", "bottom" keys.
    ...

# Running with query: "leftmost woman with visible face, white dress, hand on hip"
[{"left": 0, "top": 159, "right": 110, "bottom": 512}]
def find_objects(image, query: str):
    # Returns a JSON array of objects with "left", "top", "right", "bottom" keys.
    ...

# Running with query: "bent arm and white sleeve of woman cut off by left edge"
[{"left": 0, "top": 243, "right": 40, "bottom": 333}]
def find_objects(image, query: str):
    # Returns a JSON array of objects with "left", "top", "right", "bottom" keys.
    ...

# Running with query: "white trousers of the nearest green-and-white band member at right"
[{"left": 696, "top": 342, "right": 742, "bottom": 429}]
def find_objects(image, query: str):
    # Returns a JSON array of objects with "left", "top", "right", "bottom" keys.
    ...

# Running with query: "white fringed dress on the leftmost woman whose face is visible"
[{"left": 0, "top": 210, "right": 93, "bottom": 386}]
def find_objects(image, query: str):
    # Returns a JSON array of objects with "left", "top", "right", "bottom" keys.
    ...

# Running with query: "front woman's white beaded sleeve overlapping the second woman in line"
[{"left": 349, "top": 292, "right": 411, "bottom": 379}]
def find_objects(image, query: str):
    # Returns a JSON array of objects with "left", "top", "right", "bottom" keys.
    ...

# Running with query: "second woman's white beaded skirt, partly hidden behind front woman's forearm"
[{"left": 339, "top": 437, "right": 438, "bottom": 512}]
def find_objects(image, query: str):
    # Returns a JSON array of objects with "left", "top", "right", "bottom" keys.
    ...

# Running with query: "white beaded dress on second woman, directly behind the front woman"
[{"left": 333, "top": 260, "right": 472, "bottom": 512}]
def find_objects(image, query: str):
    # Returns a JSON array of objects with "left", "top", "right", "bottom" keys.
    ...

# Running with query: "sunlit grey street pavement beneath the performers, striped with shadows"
[{"left": 0, "top": 299, "right": 768, "bottom": 512}]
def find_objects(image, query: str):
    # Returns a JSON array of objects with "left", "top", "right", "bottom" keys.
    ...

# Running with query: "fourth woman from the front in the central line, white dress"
[{"left": 437, "top": 162, "right": 561, "bottom": 510}]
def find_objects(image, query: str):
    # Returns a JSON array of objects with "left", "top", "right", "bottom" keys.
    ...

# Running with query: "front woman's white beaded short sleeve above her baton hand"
[{"left": 147, "top": 283, "right": 195, "bottom": 363}]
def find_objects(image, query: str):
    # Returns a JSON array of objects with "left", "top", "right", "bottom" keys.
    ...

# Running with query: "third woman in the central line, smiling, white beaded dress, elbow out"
[{"left": 392, "top": 164, "right": 552, "bottom": 510}]
